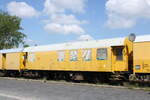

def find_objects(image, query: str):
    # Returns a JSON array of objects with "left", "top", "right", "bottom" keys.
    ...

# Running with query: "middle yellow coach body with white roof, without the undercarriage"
[{"left": 23, "top": 38, "right": 132, "bottom": 72}]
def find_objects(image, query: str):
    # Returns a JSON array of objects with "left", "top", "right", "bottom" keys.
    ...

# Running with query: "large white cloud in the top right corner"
[{"left": 105, "top": 0, "right": 150, "bottom": 28}]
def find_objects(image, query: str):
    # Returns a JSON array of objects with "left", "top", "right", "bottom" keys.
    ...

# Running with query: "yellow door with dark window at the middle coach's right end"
[{"left": 112, "top": 46, "right": 128, "bottom": 71}]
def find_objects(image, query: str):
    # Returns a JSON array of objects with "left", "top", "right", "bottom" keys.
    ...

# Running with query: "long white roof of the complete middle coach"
[{"left": 23, "top": 38, "right": 125, "bottom": 52}]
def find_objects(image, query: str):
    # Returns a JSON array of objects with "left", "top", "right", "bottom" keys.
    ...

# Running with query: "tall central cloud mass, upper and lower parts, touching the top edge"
[{"left": 43, "top": 0, "right": 87, "bottom": 34}]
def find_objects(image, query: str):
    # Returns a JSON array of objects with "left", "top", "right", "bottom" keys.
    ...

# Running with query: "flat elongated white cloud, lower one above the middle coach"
[{"left": 44, "top": 23, "right": 85, "bottom": 34}]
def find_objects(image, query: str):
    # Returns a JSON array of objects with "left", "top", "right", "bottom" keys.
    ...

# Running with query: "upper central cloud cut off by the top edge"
[{"left": 44, "top": 0, "right": 86, "bottom": 15}]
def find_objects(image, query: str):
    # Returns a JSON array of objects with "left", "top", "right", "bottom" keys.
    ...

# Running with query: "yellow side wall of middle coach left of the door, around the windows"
[{"left": 26, "top": 48, "right": 111, "bottom": 72}]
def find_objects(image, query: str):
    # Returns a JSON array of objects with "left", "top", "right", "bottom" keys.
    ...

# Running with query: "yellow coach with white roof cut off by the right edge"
[{"left": 130, "top": 35, "right": 150, "bottom": 81}]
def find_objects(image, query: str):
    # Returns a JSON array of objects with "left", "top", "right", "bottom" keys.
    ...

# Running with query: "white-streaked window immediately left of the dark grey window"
[{"left": 82, "top": 49, "right": 92, "bottom": 61}]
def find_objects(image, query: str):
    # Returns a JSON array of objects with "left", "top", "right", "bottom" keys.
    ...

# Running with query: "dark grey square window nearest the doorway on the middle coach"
[{"left": 97, "top": 48, "right": 107, "bottom": 60}]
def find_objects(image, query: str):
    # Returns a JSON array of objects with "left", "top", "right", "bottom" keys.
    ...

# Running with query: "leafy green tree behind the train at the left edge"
[{"left": 0, "top": 11, "right": 26, "bottom": 49}]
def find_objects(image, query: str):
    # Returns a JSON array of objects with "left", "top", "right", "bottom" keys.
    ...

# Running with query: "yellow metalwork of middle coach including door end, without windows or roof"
[{"left": 26, "top": 41, "right": 132, "bottom": 72}]
